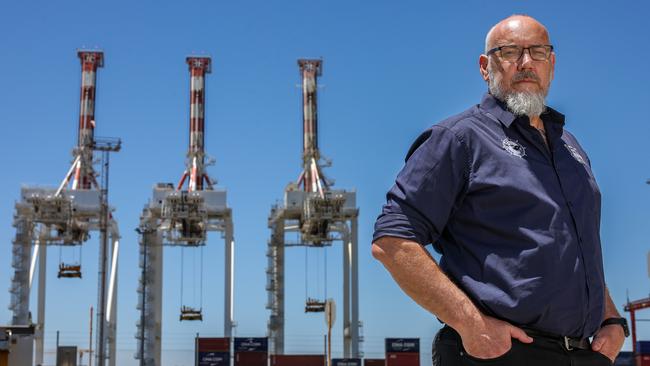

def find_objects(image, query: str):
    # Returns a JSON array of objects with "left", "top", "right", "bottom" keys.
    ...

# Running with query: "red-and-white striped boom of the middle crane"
[{"left": 177, "top": 56, "right": 212, "bottom": 191}]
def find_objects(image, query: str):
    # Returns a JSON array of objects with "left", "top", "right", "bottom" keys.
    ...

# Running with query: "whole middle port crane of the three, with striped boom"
[{"left": 135, "top": 56, "right": 234, "bottom": 366}]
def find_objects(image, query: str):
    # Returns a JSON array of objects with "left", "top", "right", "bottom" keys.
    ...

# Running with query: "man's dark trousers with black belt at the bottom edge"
[{"left": 432, "top": 326, "right": 612, "bottom": 366}]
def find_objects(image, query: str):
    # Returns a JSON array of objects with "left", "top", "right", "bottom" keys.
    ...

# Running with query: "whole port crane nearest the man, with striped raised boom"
[{"left": 266, "top": 59, "right": 361, "bottom": 358}]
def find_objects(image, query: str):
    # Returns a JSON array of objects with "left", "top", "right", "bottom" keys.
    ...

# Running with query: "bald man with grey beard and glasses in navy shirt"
[{"left": 372, "top": 15, "right": 628, "bottom": 366}]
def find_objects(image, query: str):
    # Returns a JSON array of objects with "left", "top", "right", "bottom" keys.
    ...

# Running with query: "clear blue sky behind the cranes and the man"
[{"left": 0, "top": 0, "right": 650, "bottom": 365}]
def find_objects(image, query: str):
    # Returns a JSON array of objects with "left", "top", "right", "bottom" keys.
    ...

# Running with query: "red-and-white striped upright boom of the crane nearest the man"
[{"left": 298, "top": 59, "right": 323, "bottom": 193}]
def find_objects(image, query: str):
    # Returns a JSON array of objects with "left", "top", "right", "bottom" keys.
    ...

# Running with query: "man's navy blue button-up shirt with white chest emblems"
[{"left": 373, "top": 94, "right": 605, "bottom": 337}]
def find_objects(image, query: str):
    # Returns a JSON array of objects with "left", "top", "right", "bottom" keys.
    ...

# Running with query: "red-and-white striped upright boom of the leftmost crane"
[{"left": 72, "top": 50, "right": 104, "bottom": 189}]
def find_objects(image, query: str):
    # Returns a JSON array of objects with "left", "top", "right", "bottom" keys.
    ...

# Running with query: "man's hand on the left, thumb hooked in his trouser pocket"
[{"left": 457, "top": 315, "right": 533, "bottom": 359}]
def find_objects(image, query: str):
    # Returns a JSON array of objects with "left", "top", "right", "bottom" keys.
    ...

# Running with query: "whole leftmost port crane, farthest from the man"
[{"left": 9, "top": 50, "right": 121, "bottom": 366}]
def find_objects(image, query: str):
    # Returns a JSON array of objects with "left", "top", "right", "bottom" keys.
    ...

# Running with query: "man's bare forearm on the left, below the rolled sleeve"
[{"left": 372, "top": 237, "right": 482, "bottom": 331}]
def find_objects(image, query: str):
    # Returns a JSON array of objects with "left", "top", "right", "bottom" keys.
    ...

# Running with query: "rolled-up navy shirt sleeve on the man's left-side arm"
[{"left": 373, "top": 125, "right": 470, "bottom": 245}]
